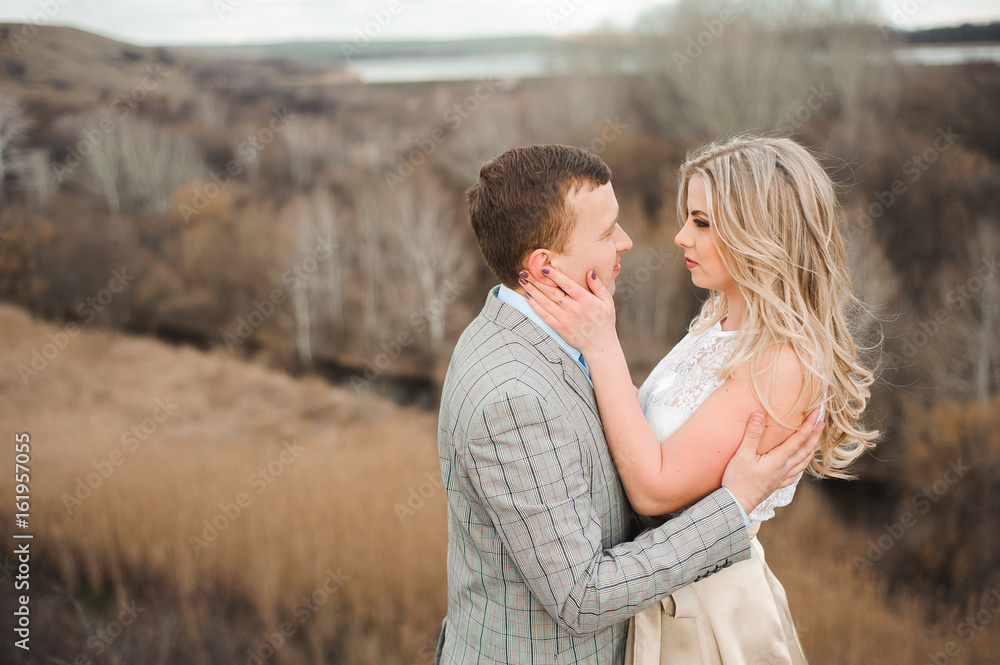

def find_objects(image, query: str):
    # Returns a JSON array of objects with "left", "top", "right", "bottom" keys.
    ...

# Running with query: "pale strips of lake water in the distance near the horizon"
[{"left": 348, "top": 44, "right": 1000, "bottom": 83}]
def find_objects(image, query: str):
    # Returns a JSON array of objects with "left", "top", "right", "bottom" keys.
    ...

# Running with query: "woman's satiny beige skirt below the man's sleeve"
[{"left": 625, "top": 525, "right": 806, "bottom": 665}]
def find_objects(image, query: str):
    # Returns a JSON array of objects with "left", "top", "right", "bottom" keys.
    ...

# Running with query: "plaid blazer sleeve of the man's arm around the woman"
[{"left": 465, "top": 394, "right": 750, "bottom": 636}]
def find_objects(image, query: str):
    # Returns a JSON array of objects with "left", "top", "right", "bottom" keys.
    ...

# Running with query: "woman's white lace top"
[{"left": 639, "top": 323, "right": 802, "bottom": 526}]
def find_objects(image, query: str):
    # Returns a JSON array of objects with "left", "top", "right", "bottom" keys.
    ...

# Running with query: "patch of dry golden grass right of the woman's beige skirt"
[{"left": 759, "top": 483, "right": 1000, "bottom": 665}]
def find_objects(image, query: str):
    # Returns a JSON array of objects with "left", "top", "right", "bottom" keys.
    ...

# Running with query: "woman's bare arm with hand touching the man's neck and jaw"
[{"left": 522, "top": 271, "right": 805, "bottom": 515}]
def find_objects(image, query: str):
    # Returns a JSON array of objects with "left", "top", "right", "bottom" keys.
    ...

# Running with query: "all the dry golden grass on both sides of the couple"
[{"left": 0, "top": 305, "right": 1000, "bottom": 665}]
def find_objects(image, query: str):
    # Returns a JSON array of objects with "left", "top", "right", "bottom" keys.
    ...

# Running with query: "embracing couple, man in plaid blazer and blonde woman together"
[{"left": 437, "top": 137, "right": 875, "bottom": 665}]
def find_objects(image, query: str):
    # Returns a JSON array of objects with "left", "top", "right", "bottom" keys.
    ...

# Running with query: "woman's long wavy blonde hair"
[{"left": 677, "top": 136, "right": 878, "bottom": 478}]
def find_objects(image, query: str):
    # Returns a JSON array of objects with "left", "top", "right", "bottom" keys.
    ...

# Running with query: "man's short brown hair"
[{"left": 466, "top": 144, "right": 611, "bottom": 288}]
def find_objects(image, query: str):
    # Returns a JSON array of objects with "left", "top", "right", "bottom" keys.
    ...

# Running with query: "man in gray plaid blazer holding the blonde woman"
[{"left": 437, "top": 145, "right": 818, "bottom": 664}]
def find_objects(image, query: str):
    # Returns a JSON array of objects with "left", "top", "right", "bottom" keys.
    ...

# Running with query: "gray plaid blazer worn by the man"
[{"left": 436, "top": 288, "right": 750, "bottom": 665}]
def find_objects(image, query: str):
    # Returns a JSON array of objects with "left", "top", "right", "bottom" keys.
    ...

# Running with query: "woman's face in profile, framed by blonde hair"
[{"left": 674, "top": 175, "right": 736, "bottom": 294}]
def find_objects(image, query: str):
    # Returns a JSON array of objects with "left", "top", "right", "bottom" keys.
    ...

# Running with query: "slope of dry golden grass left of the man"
[{"left": 0, "top": 304, "right": 447, "bottom": 663}]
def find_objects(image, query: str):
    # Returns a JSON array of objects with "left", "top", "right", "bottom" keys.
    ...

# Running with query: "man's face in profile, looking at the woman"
[{"left": 550, "top": 182, "right": 632, "bottom": 294}]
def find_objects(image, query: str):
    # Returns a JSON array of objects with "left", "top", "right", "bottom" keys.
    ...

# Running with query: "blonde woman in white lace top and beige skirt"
[{"left": 522, "top": 137, "right": 877, "bottom": 665}]
